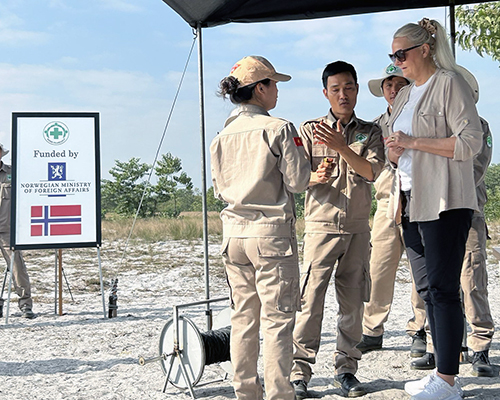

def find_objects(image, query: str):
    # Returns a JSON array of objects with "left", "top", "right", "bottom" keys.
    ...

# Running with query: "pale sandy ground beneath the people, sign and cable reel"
[{"left": 0, "top": 236, "right": 500, "bottom": 400}]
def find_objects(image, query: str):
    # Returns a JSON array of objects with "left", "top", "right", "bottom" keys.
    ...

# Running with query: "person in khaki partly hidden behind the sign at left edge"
[{"left": 0, "top": 143, "right": 35, "bottom": 319}]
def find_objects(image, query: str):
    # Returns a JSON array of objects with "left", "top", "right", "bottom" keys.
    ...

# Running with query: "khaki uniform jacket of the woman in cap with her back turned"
[{"left": 210, "top": 104, "right": 311, "bottom": 238}]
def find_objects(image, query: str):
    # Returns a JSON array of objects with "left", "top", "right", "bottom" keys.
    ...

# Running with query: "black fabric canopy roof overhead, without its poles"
[{"left": 163, "top": 0, "right": 490, "bottom": 28}]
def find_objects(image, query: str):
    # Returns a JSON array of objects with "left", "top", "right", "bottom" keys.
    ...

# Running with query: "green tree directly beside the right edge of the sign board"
[{"left": 101, "top": 158, "right": 154, "bottom": 216}]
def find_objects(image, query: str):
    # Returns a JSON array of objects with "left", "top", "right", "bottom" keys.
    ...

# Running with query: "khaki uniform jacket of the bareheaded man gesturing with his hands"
[{"left": 299, "top": 110, "right": 385, "bottom": 234}]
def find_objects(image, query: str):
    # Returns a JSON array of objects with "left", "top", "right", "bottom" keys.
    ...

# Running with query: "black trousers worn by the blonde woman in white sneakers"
[{"left": 402, "top": 192, "right": 473, "bottom": 375}]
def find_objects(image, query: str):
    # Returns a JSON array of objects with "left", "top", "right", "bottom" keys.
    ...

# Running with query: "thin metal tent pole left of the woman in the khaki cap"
[{"left": 196, "top": 23, "right": 212, "bottom": 330}]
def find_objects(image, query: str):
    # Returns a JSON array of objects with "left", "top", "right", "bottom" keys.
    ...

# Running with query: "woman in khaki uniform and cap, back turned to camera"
[{"left": 210, "top": 56, "right": 311, "bottom": 400}]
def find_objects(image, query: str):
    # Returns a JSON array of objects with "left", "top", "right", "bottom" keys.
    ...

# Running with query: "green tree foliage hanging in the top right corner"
[{"left": 456, "top": 1, "right": 500, "bottom": 61}]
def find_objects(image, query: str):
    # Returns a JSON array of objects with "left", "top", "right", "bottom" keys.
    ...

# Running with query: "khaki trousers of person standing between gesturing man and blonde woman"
[{"left": 363, "top": 199, "right": 426, "bottom": 336}]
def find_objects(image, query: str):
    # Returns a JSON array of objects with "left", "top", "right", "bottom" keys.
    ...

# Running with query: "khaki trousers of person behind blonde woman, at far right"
[{"left": 427, "top": 212, "right": 495, "bottom": 353}]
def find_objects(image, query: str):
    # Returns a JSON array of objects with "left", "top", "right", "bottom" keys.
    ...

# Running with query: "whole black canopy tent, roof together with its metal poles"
[{"left": 163, "top": 0, "right": 492, "bottom": 329}]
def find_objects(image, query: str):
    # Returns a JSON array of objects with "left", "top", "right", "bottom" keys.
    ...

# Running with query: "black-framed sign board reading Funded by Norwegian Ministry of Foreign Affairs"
[{"left": 11, "top": 113, "right": 101, "bottom": 249}]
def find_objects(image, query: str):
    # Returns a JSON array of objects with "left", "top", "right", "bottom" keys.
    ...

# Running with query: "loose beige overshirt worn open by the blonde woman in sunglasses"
[{"left": 389, "top": 69, "right": 483, "bottom": 222}]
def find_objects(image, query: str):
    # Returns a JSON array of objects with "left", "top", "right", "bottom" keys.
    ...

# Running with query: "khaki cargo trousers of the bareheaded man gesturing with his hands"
[{"left": 292, "top": 232, "right": 370, "bottom": 382}]
